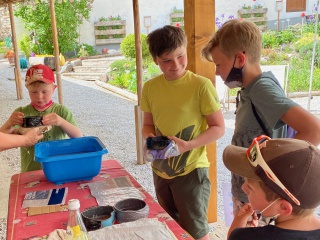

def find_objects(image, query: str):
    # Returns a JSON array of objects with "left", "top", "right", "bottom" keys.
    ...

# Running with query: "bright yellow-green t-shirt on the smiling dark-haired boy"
[{"left": 141, "top": 71, "right": 220, "bottom": 179}]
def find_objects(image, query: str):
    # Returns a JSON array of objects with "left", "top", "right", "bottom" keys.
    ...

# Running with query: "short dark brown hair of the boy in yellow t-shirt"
[{"left": 147, "top": 25, "right": 187, "bottom": 58}]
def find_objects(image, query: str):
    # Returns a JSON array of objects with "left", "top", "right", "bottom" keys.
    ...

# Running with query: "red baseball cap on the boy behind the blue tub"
[{"left": 26, "top": 64, "right": 55, "bottom": 86}]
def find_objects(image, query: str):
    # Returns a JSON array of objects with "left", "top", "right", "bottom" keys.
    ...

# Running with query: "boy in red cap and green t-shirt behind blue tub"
[{"left": 1, "top": 64, "right": 83, "bottom": 172}]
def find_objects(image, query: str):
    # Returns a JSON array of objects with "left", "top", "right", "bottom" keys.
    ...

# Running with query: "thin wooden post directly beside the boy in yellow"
[{"left": 132, "top": 0, "right": 144, "bottom": 164}]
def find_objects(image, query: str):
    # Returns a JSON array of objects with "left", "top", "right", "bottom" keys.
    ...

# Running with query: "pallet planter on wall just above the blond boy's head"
[{"left": 238, "top": 8, "right": 268, "bottom": 31}]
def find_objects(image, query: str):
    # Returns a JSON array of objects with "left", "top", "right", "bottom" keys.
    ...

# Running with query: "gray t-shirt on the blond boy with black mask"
[{"left": 231, "top": 72, "right": 298, "bottom": 202}]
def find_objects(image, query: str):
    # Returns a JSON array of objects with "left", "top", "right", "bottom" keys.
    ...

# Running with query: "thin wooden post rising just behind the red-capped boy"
[{"left": 50, "top": 0, "right": 63, "bottom": 104}]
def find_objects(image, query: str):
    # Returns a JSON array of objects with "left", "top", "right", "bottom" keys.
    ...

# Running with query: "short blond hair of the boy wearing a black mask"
[{"left": 201, "top": 19, "right": 262, "bottom": 63}]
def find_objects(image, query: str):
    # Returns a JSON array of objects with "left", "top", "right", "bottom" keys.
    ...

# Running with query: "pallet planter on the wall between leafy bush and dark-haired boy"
[{"left": 94, "top": 20, "right": 126, "bottom": 45}]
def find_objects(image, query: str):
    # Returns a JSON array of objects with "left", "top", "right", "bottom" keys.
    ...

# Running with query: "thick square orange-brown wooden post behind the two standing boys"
[{"left": 184, "top": 0, "right": 217, "bottom": 222}]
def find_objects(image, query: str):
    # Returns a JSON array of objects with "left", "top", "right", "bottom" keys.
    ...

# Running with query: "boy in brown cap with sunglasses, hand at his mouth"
[{"left": 223, "top": 135, "right": 320, "bottom": 240}]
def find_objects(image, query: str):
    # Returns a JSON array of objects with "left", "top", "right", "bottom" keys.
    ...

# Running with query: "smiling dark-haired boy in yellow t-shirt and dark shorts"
[{"left": 141, "top": 26, "right": 225, "bottom": 239}]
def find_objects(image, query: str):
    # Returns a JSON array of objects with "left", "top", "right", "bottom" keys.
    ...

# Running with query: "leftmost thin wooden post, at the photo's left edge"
[{"left": 8, "top": 3, "right": 23, "bottom": 100}]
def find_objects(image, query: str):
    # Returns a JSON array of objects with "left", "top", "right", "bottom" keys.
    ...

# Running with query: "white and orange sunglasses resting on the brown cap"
[{"left": 247, "top": 135, "right": 300, "bottom": 206}]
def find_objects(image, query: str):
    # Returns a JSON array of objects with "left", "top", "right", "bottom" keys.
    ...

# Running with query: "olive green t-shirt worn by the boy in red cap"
[{"left": 15, "top": 103, "right": 76, "bottom": 172}]
